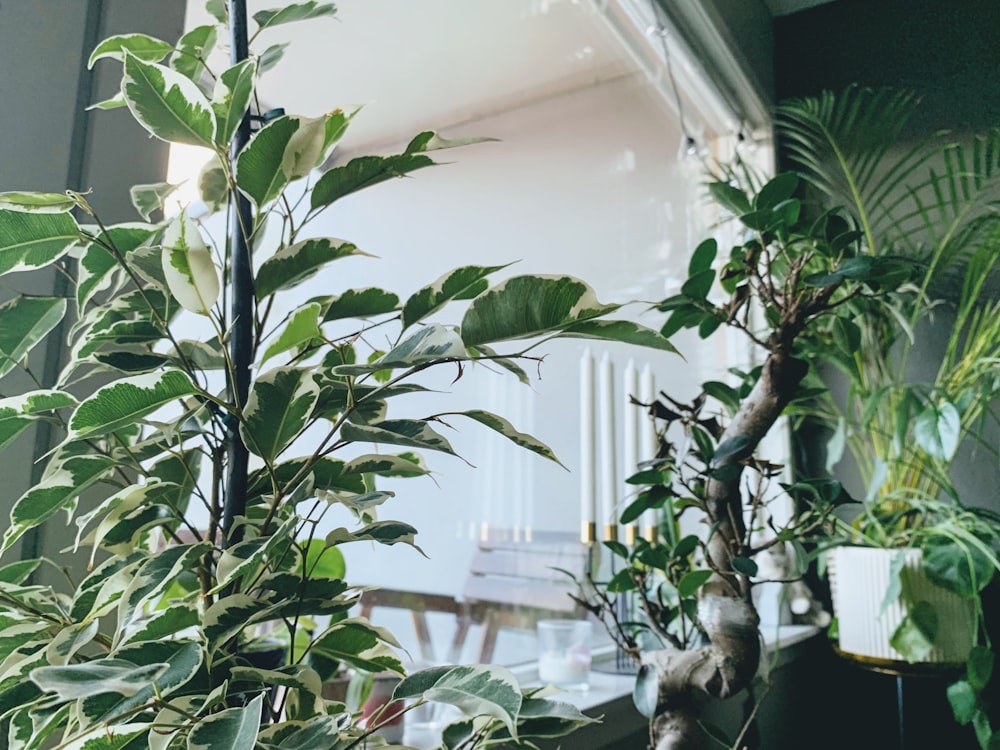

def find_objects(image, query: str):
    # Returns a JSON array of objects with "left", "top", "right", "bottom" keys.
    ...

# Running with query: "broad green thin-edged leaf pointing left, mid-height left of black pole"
[{"left": 69, "top": 370, "right": 197, "bottom": 439}]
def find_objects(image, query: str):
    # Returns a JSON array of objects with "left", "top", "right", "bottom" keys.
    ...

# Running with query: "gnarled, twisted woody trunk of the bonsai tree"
[{"left": 634, "top": 351, "right": 808, "bottom": 750}]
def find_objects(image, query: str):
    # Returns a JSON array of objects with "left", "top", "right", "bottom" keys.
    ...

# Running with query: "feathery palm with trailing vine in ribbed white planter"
[{"left": 779, "top": 88, "right": 1000, "bottom": 748}]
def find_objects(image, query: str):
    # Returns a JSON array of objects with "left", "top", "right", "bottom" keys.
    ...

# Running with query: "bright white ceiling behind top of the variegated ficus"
[{"left": 187, "top": 0, "right": 636, "bottom": 150}]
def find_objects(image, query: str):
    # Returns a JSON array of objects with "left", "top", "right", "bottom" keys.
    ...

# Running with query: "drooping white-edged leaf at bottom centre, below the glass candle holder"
[{"left": 393, "top": 664, "right": 523, "bottom": 737}]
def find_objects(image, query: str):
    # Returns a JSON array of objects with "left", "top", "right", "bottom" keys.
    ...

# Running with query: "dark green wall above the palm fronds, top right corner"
[{"left": 774, "top": 0, "right": 1000, "bottom": 132}]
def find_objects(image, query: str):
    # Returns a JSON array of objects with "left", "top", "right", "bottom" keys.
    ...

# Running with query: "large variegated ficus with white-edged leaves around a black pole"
[{"left": 0, "top": 0, "right": 671, "bottom": 750}]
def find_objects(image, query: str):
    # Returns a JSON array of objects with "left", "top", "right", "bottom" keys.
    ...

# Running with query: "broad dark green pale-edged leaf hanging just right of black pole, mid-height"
[{"left": 240, "top": 367, "right": 319, "bottom": 463}]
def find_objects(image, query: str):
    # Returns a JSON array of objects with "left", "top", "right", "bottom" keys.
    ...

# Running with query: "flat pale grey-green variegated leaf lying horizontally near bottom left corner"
[{"left": 31, "top": 659, "right": 169, "bottom": 701}]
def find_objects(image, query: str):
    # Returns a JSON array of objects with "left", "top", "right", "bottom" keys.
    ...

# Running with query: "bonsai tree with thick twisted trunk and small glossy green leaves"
[{"left": 582, "top": 156, "right": 913, "bottom": 750}]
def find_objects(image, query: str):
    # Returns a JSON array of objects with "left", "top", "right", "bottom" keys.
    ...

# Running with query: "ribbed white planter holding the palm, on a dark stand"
[{"left": 828, "top": 547, "right": 975, "bottom": 664}]
